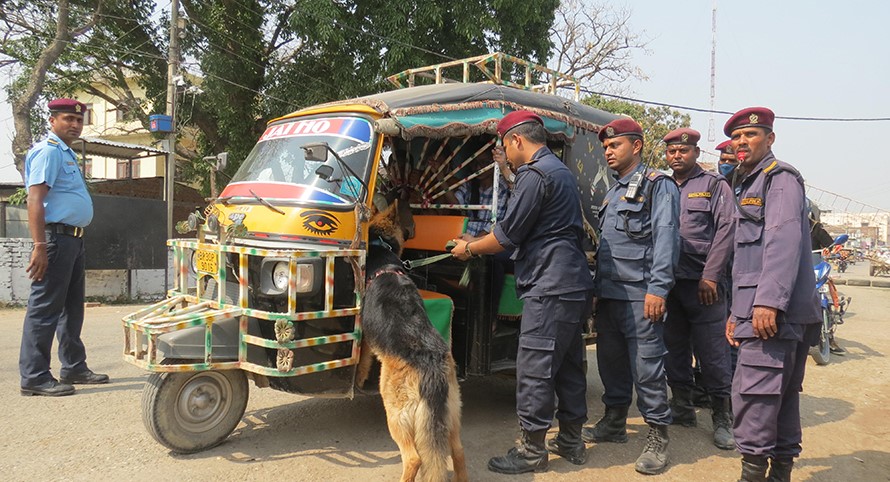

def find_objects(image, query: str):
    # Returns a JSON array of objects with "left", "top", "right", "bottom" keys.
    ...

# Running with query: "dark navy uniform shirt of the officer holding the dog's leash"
[{"left": 492, "top": 147, "right": 593, "bottom": 298}]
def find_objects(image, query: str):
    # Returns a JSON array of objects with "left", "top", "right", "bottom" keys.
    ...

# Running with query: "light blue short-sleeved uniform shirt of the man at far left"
[{"left": 25, "top": 133, "right": 93, "bottom": 227}]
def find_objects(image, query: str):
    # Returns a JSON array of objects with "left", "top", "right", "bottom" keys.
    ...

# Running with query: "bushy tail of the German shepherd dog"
[{"left": 414, "top": 355, "right": 450, "bottom": 481}]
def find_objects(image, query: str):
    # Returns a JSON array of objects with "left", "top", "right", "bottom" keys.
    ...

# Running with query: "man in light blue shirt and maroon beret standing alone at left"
[{"left": 19, "top": 99, "right": 108, "bottom": 396}]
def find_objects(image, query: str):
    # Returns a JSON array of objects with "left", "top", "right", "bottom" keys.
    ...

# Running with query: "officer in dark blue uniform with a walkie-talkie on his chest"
[{"left": 582, "top": 118, "right": 680, "bottom": 474}]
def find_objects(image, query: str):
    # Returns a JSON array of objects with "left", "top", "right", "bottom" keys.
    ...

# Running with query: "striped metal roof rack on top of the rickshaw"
[{"left": 386, "top": 52, "right": 581, "bottom": 101}]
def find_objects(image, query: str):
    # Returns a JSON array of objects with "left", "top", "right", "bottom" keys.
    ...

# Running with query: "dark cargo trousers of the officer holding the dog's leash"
[{"left": 516, "top": 291, "right": 591, "bottom": 432}]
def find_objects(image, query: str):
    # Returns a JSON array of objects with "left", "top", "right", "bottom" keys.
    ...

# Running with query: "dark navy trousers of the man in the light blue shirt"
[{"left": 19, "top": 233, "right": 87, "bottom": 387}]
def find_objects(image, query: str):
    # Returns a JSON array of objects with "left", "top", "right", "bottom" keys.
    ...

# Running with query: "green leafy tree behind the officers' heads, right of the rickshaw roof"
[{"left": 582, "top": 94, "right": 691, "bottom": 169}]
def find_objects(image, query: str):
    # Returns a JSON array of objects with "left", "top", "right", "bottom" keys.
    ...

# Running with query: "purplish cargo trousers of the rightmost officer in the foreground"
[{"left": 732, "top": 324, "right": 820, "bottom": 457}]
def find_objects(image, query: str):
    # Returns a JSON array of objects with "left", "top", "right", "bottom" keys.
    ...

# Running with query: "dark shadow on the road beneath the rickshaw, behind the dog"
[{"left": 171, "top": 377, "right": 518, "bottom": 470}]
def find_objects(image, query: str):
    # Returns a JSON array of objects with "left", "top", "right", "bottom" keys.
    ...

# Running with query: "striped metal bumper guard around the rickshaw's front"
[{"left": 123, "top": 239, "right": 365, "bottom": 377}]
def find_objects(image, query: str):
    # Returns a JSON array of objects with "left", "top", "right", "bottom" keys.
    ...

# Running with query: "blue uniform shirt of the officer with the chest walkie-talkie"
[{"left": 594, "top": 163, "right": 680, "bottom": 301}]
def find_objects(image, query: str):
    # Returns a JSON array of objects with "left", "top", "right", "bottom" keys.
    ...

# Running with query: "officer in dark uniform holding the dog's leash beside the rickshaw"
[{"left": 451, "top": 110, "right": 593, "bottom": 474}]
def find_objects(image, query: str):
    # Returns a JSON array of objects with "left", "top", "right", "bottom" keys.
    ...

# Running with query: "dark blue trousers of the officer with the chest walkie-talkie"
[{"left": 596, "top": 299, "right": 672, "bottom": 425}]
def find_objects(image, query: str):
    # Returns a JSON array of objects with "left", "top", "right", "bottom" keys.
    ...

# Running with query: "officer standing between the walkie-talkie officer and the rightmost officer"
[{"left": 664, "top": 127, "right": 735, "bottom": 450}]
